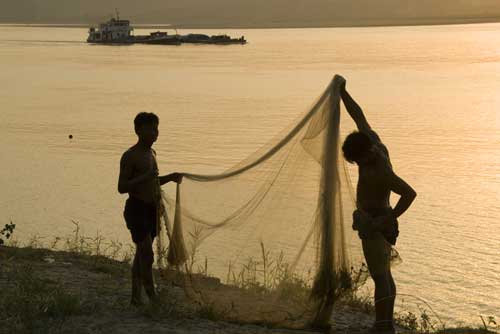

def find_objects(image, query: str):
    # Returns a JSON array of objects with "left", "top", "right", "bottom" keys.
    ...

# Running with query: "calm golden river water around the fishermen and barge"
[{"left": 0, "top": 24, "right": 500, "bottom": 323}]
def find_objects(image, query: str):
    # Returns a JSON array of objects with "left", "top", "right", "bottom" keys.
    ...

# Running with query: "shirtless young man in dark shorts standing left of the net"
[{"left": 118, "top": 112, "right": 182, "bottom": 306}]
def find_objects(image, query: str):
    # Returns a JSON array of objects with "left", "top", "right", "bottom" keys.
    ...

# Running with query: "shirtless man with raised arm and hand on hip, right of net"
[{"left": 341, "top": 80, "right": 417, "bottom": 334}]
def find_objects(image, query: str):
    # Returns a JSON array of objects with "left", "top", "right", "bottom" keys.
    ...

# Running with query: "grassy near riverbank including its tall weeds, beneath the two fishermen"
[{"left": 0, "top": 223, "right": 498, "bottom": 334}]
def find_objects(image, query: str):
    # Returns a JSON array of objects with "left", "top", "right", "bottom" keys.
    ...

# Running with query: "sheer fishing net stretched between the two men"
[{"left": 158, "top": 77, "right": 368, "bottom": 327}]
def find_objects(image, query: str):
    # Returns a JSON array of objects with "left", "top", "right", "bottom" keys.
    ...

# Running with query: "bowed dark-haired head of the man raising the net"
[{"left": 342, "top": 131, "right": 376, "bottom": 166}]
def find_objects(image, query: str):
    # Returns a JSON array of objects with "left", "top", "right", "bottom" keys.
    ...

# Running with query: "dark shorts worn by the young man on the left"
[{"left": 123, "top": 197, "right": 158, "bottom": 243}]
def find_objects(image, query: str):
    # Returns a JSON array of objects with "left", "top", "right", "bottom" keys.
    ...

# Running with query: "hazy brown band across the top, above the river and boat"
[{"left": 0, "top": 0, "right": 500, "bottom": 27}]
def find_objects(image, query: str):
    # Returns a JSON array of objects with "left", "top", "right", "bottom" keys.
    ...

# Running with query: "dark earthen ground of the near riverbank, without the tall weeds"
[{"left": 0, "top": 246, "right": 494, "bottom": 334}]
